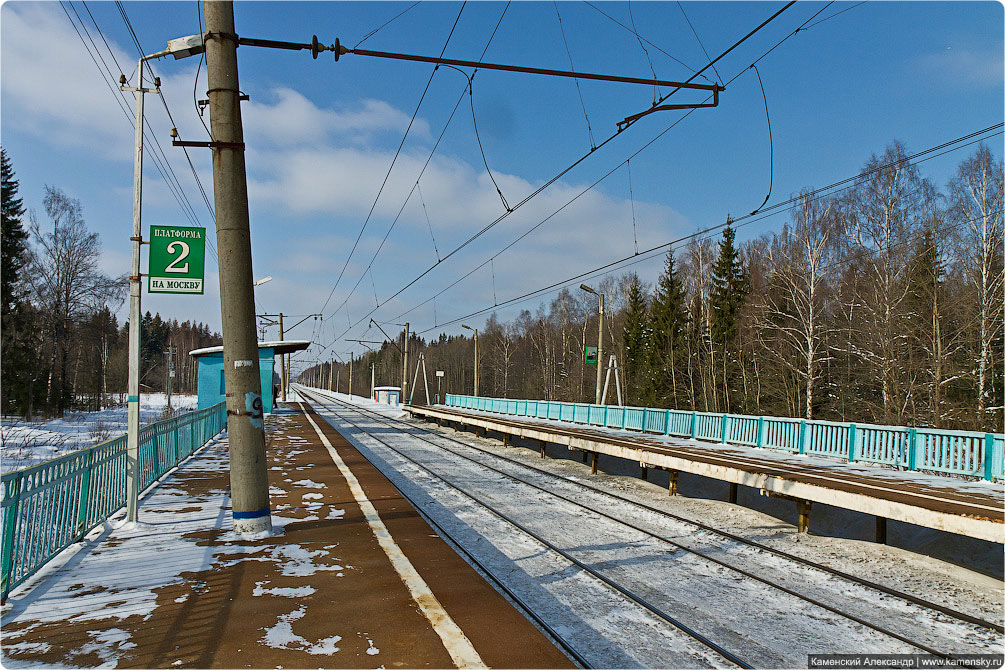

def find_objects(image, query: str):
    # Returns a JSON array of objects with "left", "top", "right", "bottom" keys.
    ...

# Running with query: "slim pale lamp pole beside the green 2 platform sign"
[{"left": 126, "top": 66, "right": 146, "bottom": 521}]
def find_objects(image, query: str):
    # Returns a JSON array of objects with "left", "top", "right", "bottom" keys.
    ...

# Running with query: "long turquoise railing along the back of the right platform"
[{"left": 445, "top": 394, "right": 1005, "bottom": 481}]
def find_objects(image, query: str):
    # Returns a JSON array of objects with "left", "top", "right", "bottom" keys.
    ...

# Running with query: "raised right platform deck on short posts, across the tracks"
[{"left": 403, "top": 405, "right": 1005, "bottom": 542}]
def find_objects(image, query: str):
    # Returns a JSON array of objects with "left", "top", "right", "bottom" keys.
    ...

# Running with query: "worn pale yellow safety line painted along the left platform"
[{"left": 299, "top": 403, "right": 488, "bottom": 668}]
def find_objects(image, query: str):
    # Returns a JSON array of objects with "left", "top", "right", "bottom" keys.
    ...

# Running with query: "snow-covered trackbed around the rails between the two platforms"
[{"left": 303, "top": 389, "right": 1001, "bottom": 667}]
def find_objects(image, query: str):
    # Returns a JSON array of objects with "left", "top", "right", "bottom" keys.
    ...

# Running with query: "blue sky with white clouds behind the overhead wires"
[{"left": 0, "top": 0, "right": 1003, "bottom": 371}]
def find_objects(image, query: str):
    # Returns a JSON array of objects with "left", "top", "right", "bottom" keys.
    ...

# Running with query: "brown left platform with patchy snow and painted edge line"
[{"left": 2, "top": 404, "right": 575, "bottom": 668}]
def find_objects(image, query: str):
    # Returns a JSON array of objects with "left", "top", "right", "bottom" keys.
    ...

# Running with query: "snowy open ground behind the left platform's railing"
[{"left": 0, "top": 393, "right": 199, "bottom": 472}]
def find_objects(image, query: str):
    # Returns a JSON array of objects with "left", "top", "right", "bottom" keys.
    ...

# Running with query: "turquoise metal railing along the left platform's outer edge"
[{"left": 0, "top": 403, "right": 227, "bottom": 599}]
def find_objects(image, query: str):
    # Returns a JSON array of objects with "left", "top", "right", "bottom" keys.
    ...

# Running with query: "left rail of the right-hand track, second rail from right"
[{"left": 301, "top": 389, "right": 969, "bottom": 659}]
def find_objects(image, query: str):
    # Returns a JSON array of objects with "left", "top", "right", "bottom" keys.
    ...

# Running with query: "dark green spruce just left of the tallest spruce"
[{"left": 650, "top": 250, "right": 687, "bottom": 409}]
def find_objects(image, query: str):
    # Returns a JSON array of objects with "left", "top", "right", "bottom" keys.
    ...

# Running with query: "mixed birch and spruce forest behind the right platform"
[{"left": 309, "top": 142, "right": 1005, "bottom": 431}]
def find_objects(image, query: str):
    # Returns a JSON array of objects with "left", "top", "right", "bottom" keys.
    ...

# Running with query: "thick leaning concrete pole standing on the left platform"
[{"left": 204, "top": 0, "right": 272, "bottom": 535}]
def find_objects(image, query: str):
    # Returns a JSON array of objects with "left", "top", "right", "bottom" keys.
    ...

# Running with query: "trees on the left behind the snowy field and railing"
[{"left": 0, "top": 152, "right": 222, "bottom": 416}]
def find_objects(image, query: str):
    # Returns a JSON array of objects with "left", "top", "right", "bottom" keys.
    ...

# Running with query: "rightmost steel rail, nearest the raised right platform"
[{"left": 305, "top": 389, "right": 1005, "bottom": 644}]
